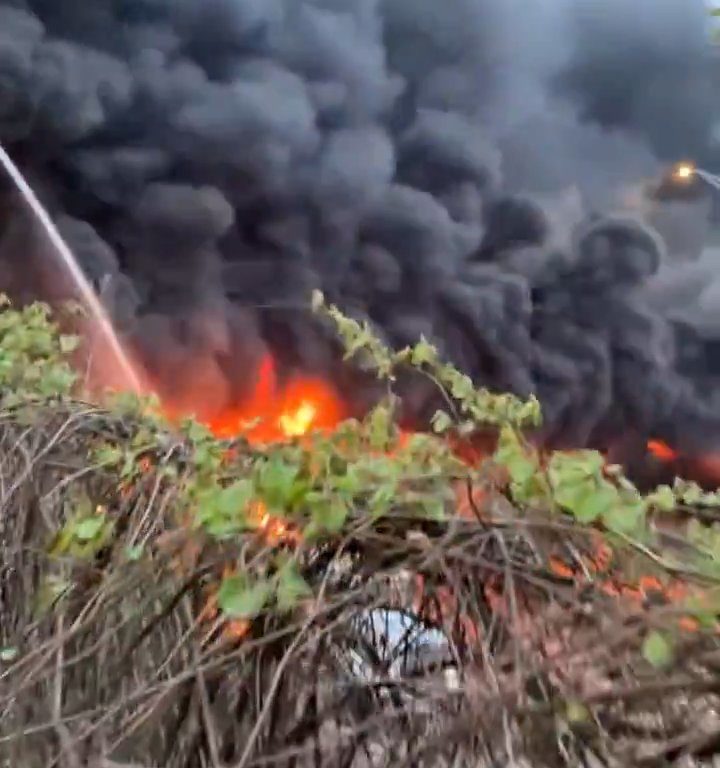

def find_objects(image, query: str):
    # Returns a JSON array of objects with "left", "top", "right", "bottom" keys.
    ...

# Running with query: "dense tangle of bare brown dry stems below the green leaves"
[{"left": 0, "top": 405, "right": 720, "bottom": 768}]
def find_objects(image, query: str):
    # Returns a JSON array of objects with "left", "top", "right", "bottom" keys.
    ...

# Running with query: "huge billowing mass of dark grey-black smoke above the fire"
[{"left": 0, "top": 0, "right": 720, "bottom": 456}]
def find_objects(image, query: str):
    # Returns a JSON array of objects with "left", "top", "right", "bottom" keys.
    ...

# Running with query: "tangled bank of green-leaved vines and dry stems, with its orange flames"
[{"left": 0, "top": 296, "right": 720, "bottom": 768}]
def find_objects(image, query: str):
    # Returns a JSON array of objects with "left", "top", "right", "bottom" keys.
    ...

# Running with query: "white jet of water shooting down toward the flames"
[{"left": 0, "top": 145, "right": 142, "bottom": 394}]
